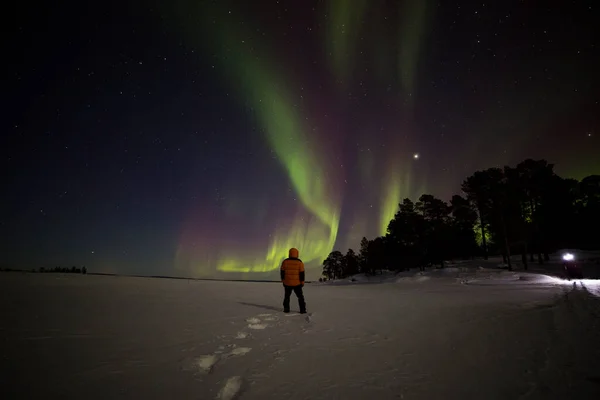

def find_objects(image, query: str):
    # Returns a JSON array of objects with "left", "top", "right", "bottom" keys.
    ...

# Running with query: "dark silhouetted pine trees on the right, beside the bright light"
[{"left": 322, "top": 159, "right": 600, "bottom": 279}]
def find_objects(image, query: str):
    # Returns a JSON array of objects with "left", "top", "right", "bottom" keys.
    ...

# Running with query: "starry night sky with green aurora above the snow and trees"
[{"left": 0, "top": 0, "right": 600, "bottom": 279}]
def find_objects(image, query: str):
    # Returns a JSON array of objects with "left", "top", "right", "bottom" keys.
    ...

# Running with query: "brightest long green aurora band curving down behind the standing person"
[{"left": 173, "top": 0, "right": 340, "bottom": 272}]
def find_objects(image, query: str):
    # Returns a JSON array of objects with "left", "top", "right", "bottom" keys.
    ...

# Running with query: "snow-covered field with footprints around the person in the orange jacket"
[{"left": 0, "top": 264, "right": 600, "bottom": 400}]
